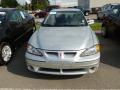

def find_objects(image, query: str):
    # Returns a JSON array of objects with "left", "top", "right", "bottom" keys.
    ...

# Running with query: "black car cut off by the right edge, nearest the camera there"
[{"left": 102, "top": 4, "right": 120, "bottom": 37}]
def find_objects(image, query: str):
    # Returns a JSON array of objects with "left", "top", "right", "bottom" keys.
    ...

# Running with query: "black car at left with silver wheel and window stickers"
[{"left": 0, "top": 8, "right": 36, "bottom": 65}]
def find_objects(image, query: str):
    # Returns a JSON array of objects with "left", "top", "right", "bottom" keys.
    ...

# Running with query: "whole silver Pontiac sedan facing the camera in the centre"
[{"left": 25, "top": 9, "right": 100, "bottom": 75}]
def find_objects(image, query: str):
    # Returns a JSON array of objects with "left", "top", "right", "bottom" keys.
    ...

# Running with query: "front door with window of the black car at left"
[{"left": 9, "top": 10, "right": 24, "bottom": 41}]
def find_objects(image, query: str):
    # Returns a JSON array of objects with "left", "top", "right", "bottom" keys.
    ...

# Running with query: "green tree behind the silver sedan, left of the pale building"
[{"left": 32, "top": 0, "right": 49, "bottom": 10}]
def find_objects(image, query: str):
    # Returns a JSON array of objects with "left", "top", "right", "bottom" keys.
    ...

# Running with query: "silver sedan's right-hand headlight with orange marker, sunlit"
[{"left": 80, "top": 44, "right": 100, "bottom": 57}]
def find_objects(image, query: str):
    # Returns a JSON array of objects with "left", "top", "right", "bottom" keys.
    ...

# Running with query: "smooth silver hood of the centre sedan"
[{"left": 30, "top": 26, "right": 94, "bottom": 50}]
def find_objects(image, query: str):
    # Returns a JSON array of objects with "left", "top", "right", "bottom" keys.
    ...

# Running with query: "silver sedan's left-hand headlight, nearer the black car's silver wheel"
[{"left": 27, "top": 44, "right": 43, "bottom": 56}]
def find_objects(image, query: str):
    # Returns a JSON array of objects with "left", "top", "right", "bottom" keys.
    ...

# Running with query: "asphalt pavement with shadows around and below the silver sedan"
[{"left": 0, "top": 32, "right": 120, "bottom": 89}]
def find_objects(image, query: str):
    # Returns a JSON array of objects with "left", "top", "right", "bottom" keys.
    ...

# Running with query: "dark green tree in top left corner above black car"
[{"left": 1, "top": 0, "right": 18, "bottom": 8}]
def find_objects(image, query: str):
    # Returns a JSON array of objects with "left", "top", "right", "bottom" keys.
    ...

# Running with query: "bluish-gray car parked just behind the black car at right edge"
[{"left": 97, "top": 3, "right": 118, "bottom": 20}]
